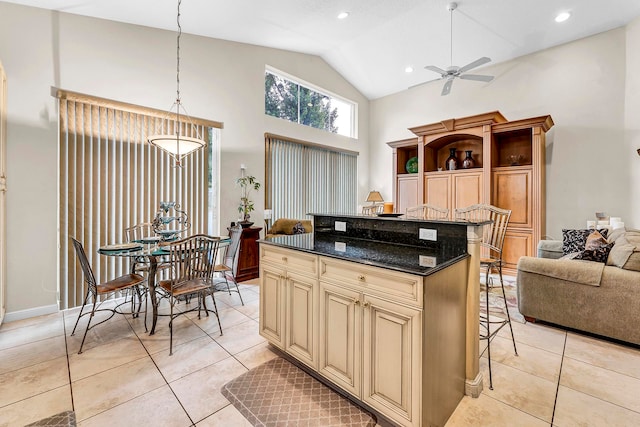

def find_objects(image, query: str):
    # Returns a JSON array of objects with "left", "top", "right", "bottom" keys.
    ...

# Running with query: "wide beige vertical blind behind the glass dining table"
[{"left": 58, "top": 92, "right": 218, "bottom": 309}]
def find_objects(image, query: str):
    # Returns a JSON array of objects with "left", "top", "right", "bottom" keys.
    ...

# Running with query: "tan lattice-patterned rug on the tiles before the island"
[{"left": 222, "top": 357, "right": 376, "bottom": 427}]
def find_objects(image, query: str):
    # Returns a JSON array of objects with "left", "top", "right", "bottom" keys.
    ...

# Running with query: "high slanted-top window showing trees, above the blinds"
[{"left": 264, "top": 69, "right": 357, "bottom": 138}]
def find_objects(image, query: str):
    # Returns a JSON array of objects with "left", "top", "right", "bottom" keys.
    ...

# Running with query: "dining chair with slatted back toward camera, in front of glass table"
[{"left": 157, "top": 234, "right": 222, "bottom": 355}]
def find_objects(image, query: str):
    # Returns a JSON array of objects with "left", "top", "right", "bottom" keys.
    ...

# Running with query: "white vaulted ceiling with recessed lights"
[{"left": 5, "top": 0, "right": 640, "bottom": 99}]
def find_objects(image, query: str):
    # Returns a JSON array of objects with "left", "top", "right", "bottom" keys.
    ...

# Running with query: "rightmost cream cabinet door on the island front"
[{"left": 362, "top": 295, "right": 422, "bottom": 426}]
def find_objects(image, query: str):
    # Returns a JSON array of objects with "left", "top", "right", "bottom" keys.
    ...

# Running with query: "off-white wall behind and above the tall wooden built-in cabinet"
[{"left": 369, "top": 27, "right": 640, "bottom": 238}]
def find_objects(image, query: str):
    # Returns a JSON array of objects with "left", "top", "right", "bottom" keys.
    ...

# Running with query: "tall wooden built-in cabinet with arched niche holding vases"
[{"left": 388, "top": 111, "right": 553, "bottom": 272}]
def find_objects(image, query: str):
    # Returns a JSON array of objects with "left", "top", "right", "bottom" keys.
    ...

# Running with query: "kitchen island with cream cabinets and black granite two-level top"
[{"left": 260, "top": 214, "right": 482, "bottom": 426}]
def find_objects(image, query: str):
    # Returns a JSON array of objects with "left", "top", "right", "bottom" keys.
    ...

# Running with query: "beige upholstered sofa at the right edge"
[{"left": 516, "top": 229, "right": 640, "bottom": 345}]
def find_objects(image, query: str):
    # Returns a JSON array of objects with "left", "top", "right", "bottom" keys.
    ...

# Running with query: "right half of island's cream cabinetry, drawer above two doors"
[{"left": 319, "top": 257, "right": 422, "bottom": 426}]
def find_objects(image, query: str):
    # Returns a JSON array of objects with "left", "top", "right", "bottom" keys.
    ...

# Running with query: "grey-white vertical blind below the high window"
[{"left": 265, "top": 135, "right": 358, "bottom": 219}]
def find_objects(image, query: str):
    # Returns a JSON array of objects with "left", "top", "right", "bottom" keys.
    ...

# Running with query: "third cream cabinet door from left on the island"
[{"left": 318, "top": 281, "right": 362, "bottom": 397}]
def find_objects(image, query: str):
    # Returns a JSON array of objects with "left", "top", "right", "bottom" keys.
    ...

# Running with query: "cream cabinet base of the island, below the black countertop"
[{"left": 260, "top": 244, "right": 467, "bottom": 426}]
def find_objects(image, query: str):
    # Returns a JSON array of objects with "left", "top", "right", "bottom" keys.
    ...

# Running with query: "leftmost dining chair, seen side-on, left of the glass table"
[{"left": 71, "top": 237, "right": 147, "bottom": 354}]
